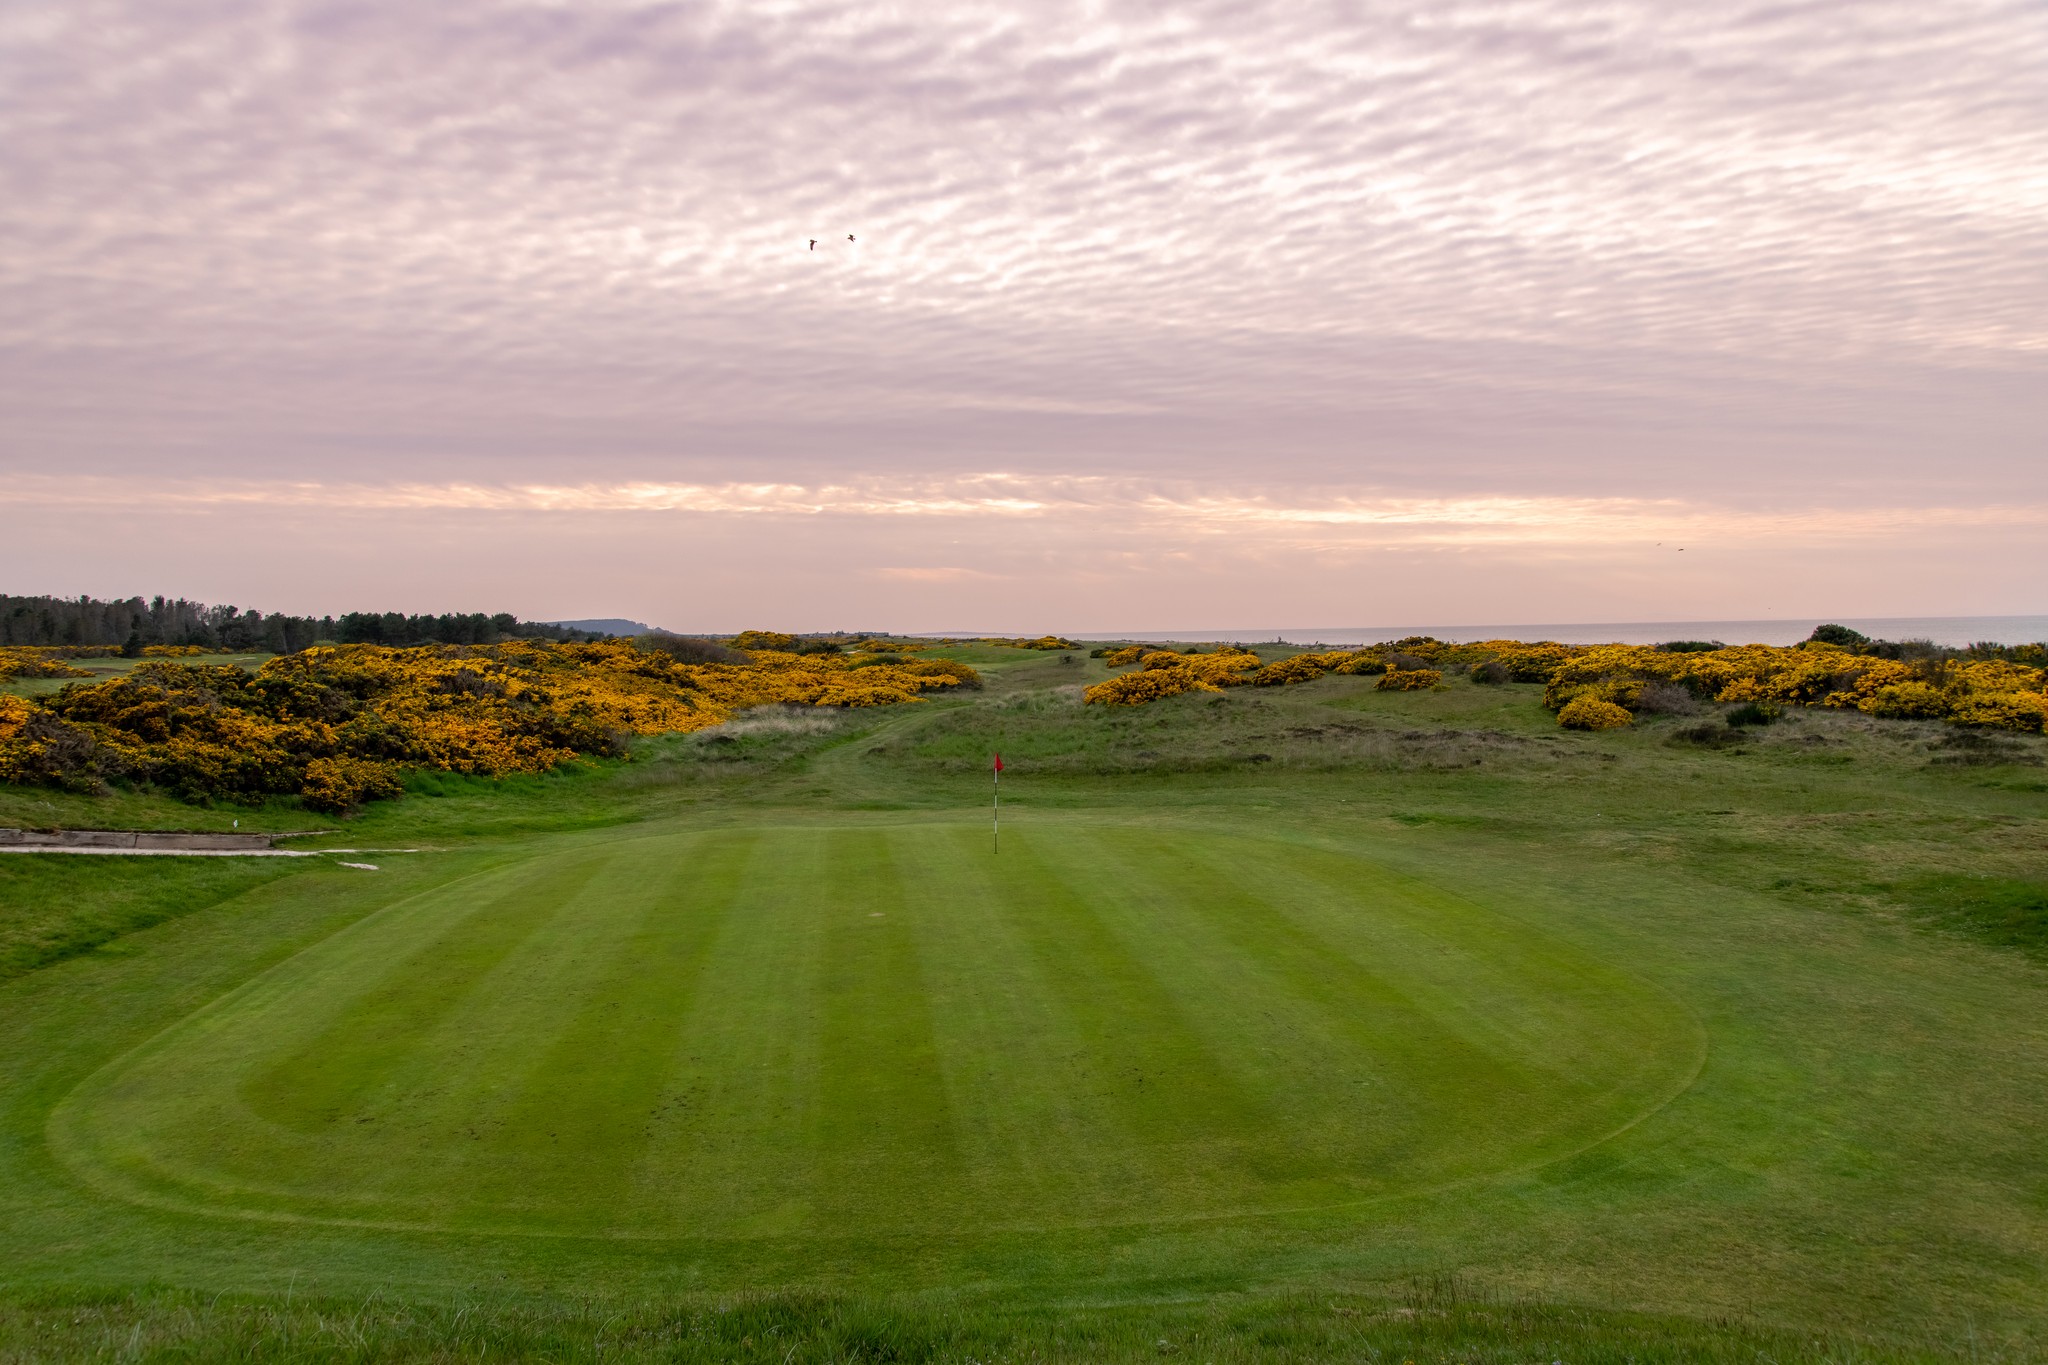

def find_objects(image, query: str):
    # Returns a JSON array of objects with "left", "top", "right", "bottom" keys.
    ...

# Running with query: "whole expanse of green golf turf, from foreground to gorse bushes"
[{"left": 0, "top": 649, "right": 2048, "bottom": 1361}]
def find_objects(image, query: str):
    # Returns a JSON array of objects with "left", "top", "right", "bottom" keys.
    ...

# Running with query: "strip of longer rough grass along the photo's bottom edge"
[{"left": 0, "top": 1281, "right": 1927, "bottom": 1365}]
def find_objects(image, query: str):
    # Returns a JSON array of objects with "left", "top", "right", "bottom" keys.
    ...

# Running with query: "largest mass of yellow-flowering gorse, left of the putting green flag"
[{"left": 0, "top": 641, "right": 979, "bottom": 808}]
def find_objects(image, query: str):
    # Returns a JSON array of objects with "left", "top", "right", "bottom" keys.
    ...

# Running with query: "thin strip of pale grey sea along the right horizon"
[{"left": 1067, "top": 616, "right": 2048, "bottom": 647}]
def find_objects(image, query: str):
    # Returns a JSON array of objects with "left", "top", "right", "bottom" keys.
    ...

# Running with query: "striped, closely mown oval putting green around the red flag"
[{"left": 51, "top": 821, "right": 1700, "bottom": 1236}]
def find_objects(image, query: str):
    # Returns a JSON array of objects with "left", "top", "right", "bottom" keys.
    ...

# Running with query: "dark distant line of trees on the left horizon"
[{"left": 0, "top": 596, "right": 604, "bottom": 655}]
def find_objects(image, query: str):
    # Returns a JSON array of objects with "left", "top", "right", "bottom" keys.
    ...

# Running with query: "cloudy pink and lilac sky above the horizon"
[{"left": 0, "top": 0, "right": 2048, "bottom": 634}]
